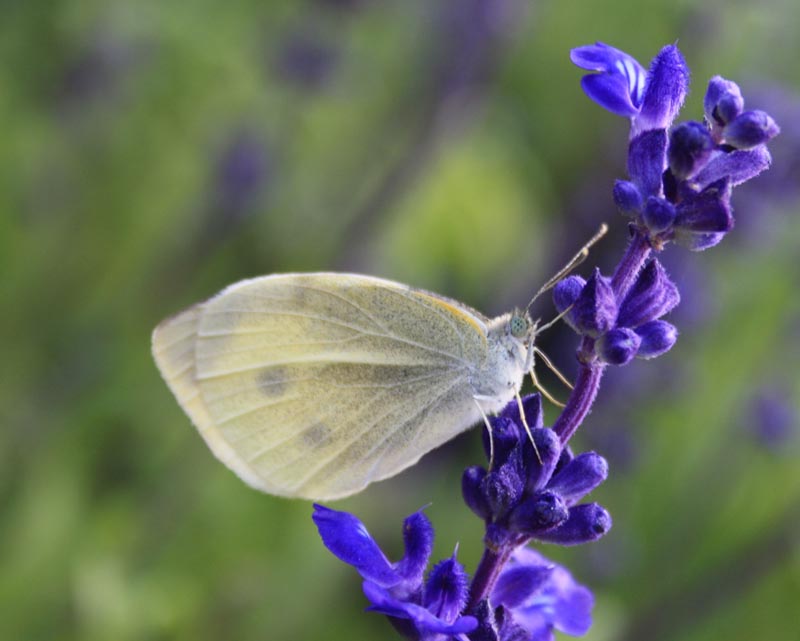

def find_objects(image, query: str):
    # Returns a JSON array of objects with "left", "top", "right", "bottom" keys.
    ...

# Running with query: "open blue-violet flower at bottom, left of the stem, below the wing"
[{"left": 313, "top": 505, "right": 478, "bottom": 641}]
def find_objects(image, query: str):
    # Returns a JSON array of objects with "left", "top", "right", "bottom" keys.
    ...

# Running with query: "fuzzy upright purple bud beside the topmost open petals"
[{"left": 631, "top": 45, "right": 689, "bottom": 138}]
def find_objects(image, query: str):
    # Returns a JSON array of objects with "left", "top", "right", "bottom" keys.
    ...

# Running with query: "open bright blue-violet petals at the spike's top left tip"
[{"left": 569, "top": 42, "right": 646, "bottom": 117}]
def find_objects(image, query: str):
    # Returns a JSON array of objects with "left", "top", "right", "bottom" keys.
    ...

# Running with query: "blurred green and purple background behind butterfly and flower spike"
[{"left": 0, "top": 0, "right": 800, "bottom": 641}]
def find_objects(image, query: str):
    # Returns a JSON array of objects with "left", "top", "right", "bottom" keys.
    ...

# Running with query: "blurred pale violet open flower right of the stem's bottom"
[{"left": 490, "top": 548, "right": 594, "bottom": 641}]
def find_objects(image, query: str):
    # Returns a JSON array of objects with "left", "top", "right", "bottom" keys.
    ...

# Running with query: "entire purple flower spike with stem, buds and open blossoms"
[{"left": 314, "top": 43, "right": 779, "bottom": 641}]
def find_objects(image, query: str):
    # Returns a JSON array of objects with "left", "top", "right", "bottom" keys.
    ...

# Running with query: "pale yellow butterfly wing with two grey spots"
[{"left": 153, "top": 273, "right": 487, "bottom": 500}]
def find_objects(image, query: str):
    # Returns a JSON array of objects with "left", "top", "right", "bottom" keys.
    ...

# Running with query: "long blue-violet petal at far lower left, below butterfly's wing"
[{"left": 312, "top": 504, "right": 403, "bottom": 587}]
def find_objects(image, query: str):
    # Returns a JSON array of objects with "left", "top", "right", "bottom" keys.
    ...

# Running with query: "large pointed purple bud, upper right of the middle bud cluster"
[{"left": 617, "top": 258, "right": 681, "bottom": 327}]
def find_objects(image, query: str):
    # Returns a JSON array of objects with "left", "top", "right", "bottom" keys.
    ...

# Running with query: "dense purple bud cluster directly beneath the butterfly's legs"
[{"left": 462, "top": 394, "right": 611, "bottom": 549}]
